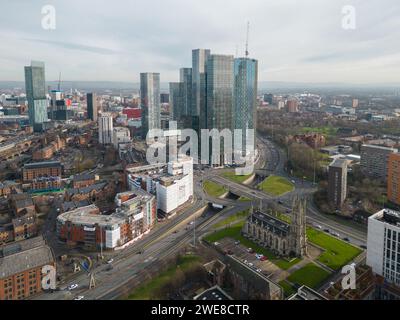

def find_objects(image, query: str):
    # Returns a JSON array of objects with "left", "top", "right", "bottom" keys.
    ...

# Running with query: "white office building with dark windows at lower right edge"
[{"left": 367, "top": 209, "right": 400, "bottom": 285}]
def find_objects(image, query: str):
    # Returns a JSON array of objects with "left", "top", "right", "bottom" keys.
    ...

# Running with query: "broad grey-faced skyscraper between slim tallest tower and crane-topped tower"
[{"left": 205, "top": 54, "right": 233, "bottom": 130}]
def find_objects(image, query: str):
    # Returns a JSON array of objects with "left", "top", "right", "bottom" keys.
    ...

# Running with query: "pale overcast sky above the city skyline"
[{"left": 0, "top": 0, "right": 400, "bottom": 84}]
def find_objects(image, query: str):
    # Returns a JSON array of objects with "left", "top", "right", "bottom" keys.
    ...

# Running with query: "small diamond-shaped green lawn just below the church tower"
[{"left": 286, "top": 263, "right": 330, "bottom": 289}]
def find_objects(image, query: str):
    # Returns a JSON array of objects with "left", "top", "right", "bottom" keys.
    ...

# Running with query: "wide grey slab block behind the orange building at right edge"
[{"left": 360, "top": 144, "right": 397, "bottom": 181}]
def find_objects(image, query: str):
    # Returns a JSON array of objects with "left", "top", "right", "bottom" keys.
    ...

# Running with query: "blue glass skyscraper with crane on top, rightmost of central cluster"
[{"left": 233, "top": 58, "right": 258, "bottom": 154}]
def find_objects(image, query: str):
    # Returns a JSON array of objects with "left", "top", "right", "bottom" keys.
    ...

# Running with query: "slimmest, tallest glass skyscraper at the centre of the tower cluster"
[{"left": 191, "top": 49, "right": 210, "bottom": 130}]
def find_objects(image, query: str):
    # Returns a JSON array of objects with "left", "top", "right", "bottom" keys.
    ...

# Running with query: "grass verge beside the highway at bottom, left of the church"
[{"left": 128, "top": 256, "right": 200, "bottom": 300}]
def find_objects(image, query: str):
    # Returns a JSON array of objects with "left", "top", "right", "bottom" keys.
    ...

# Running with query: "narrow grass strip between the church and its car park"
[{"left": 204, "top": 221, "right": 300, "bottom": 270}]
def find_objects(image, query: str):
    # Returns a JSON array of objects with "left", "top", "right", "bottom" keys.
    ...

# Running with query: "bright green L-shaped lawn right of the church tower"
[{"left": 307, "top": 227, "right": 362, "bottom": 270}]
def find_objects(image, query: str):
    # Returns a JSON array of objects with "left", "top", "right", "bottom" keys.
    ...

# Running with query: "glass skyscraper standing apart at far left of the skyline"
[{"left": 25, "top": 61, "right": 48, "bottom": 131}]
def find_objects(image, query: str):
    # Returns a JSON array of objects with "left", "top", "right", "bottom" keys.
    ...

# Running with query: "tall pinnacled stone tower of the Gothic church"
[{"left": 289, "top": 197, "right": 307, "bottom": 257}]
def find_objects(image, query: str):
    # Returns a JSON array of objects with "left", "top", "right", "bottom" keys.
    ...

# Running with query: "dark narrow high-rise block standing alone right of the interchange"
[{"left": 328, "top": 159, "right": 347, "bottom": 209}]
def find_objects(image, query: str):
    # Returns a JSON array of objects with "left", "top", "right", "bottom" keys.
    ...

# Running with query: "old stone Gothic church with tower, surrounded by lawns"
[{"left": 242, "top": 198, "right": 307, "bottom": 257}]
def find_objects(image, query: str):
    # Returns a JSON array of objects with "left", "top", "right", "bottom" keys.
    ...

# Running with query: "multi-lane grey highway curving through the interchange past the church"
[{"left": 35, "top": 132, "right": 366, "bottom": 300}]
